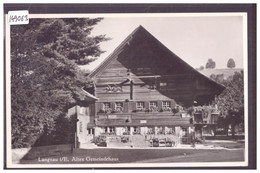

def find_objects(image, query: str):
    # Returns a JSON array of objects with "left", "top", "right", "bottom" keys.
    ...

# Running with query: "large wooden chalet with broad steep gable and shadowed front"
[{"left": 69, "top": 26, "right": 224, "bottom": 147}]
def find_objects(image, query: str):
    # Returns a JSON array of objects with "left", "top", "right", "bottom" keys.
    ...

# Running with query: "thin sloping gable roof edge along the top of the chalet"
[{"left": 88, "top": 25, "right": 225, "bottom": 92}]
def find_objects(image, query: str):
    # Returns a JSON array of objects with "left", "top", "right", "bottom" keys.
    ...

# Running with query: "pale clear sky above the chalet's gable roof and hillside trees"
[{"left": 85, "top": 16, "right": 243, "bottom": 70}]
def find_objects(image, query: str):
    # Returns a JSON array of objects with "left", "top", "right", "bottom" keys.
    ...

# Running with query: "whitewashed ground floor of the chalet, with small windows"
[{"left": 78, "top": 126, "right": 194, "bottom": 147}]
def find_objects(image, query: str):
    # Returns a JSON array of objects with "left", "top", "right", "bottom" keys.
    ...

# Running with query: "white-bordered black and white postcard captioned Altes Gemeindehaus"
[{"left": 5, "top": 4, "right": 255, "bottom": 168}]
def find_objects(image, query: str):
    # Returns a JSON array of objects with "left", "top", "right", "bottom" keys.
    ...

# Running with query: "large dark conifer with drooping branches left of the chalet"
[{"left": 11, "top": 18, "right": 108, "bottom": 148}]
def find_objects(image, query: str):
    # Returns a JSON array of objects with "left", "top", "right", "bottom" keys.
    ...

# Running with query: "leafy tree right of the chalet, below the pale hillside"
[{"left": 211, "top": 71, "right": 244, "bottom": 136}]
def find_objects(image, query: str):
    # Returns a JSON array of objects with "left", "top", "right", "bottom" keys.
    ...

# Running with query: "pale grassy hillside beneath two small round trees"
[{"left": 198, "top": 68, "right": 243, "bottom": 78}]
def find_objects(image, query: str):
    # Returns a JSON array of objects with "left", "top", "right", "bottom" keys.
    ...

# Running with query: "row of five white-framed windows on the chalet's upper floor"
[{"left": 103, "top": 101, "right": 171, "bottom": 110}]
